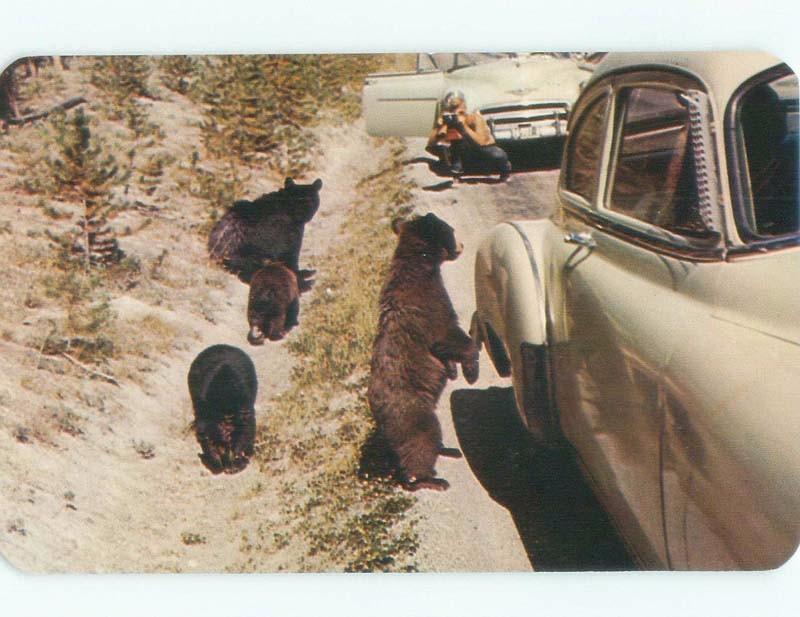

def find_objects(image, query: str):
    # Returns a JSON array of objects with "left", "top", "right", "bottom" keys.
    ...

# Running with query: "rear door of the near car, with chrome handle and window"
[{"left": 553, "top": 72, "right": 720, "bottom": 567}]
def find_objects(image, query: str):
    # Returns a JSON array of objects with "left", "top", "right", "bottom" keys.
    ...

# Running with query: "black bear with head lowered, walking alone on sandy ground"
[{"left": 189, "top": 345, "right": 258, "bottom": 474}]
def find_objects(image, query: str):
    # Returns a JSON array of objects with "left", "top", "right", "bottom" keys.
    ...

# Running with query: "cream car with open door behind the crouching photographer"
[{"left": 363, "top": 53, "right": 594, "bottom": 149}]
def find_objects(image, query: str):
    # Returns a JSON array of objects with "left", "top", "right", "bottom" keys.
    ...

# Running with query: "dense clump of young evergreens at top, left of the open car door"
[{"left": 198, "top": 55, "right": 388, "bottom": 175}]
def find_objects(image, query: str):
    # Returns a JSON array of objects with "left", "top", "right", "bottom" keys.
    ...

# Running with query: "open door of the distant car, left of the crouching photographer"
[{"left": 363, "top": 54, "right": 445, "bottom": 137}]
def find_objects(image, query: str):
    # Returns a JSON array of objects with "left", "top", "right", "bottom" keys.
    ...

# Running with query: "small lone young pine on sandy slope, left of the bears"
[{"left": 49, "top": 109, "right": 124, "bottom": 265}]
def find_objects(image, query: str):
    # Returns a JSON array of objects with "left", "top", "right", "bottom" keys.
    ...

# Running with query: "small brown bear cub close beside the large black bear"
[{"left": 247, "top": 262, "right": 300, "bottom": 345}]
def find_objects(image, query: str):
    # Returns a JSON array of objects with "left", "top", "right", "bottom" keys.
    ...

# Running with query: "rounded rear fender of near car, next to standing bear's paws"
[{"left": 473, "top": 220, "right": 557, "bottom": 442}]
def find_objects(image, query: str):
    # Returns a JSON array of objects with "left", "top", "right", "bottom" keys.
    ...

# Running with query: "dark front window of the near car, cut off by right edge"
[{"left": 739, "top": 73, "right": 800, "bottom": 236}]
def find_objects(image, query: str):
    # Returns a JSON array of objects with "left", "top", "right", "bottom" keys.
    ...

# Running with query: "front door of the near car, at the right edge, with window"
[{"left": 663, "top": 67, "right": 800, "bottom": 569}]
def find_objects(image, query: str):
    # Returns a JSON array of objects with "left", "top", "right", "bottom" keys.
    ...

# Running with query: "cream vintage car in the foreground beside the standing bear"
[{"left": 473, "top": 53, "right": 800, "bottom": 569}]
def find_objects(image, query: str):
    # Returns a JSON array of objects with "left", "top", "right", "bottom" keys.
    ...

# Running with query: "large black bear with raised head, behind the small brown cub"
[{"left": 208, "top": 178, "right": 322, "bottom": 287}]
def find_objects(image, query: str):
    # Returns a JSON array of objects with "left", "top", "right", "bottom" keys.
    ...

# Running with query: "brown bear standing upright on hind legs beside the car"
[{"left": 367, "top": 214, "right": 478, "bottom": 490}]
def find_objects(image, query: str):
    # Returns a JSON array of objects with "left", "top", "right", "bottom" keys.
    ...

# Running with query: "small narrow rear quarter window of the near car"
[{"left": 564, "top": 95, "right": 608, "bottom": 203}]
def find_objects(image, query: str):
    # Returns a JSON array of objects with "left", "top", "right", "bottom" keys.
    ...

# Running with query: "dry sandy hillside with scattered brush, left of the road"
[{"left": 0, "top": 58, "right": 434, "bottom": 571}]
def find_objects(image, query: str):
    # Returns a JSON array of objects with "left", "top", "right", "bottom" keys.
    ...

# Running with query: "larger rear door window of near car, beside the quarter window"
[{"left": 607, "top": 87, "right": 710, "bottom": 237}]
